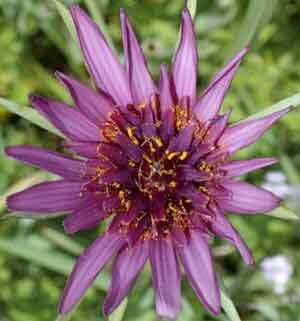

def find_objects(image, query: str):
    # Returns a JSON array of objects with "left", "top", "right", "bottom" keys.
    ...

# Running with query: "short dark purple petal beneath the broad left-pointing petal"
[{"left": 64, "top": 199, "right": 105, "bottom": 234}]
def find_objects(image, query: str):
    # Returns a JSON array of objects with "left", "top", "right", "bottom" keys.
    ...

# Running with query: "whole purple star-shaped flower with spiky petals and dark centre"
[{"left": 6, "top": 6, "right": 289, "bottom": 318}]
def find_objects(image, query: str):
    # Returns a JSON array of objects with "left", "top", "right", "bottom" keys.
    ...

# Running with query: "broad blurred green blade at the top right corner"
[{"left": 227, "top": 0, "right": 278, "bottom": 58}]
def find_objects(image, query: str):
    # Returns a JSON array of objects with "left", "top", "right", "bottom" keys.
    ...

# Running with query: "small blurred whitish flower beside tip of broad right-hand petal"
[{"left": 262, "top": 171, "right": 293, "bottom": 199}]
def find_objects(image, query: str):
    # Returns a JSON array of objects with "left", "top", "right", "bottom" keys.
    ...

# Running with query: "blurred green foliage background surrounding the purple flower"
[{"left": 0, "top": 0, "right": 300, "bottom": 321}]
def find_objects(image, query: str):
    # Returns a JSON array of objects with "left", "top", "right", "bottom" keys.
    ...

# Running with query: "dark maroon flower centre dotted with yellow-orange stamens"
[{"left": 80, "top": 97, "right": 227, "bottom": 242}]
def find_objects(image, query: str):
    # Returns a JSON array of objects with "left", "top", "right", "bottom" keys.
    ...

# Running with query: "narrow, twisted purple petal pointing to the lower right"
[{"left": 211, "top": 211, "right": 254, "bottom": 265}]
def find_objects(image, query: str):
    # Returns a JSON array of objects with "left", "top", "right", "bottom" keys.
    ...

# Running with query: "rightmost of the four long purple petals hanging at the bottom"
[{"left": 177, "top": 231, "right": 221, "bottom": 314}]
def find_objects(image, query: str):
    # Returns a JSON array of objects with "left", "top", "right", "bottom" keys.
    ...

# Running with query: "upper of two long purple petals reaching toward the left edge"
[{"left": 5, "top": 145, "right": 83, "bottom": 181}]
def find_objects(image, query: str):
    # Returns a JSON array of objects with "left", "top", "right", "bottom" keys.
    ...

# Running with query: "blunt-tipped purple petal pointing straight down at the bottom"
[{"left": 150, "top": 239, "right": 181, "bottom": 319}]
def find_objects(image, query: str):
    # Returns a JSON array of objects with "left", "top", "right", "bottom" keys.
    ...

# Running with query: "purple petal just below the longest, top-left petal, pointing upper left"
[{"left": 56, "top": 72, "right": 114, "bottom": 125}]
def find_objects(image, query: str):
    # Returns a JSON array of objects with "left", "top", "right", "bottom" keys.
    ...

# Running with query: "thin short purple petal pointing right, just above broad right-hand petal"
[{"left": 220, "top": 157, "right": 278, "bottom": 177}]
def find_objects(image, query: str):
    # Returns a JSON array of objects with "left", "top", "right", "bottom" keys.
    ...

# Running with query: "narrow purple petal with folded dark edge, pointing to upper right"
[{"left": 194, "top": 48, "right": 248, "bottom": 123}]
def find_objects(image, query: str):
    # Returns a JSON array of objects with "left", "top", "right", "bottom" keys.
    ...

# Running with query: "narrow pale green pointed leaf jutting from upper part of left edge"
[{"left": 0, "top": 98, "right": 64, "bottom": 137}]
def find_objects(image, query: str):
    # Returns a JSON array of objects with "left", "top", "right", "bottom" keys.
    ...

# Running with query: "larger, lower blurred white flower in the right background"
[{"left": 260, "top": 255, "right": 293, "bottom": 294}]
